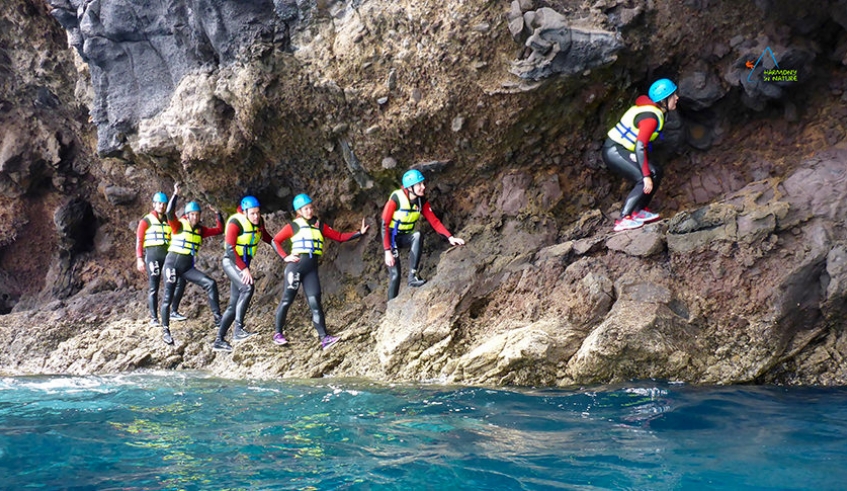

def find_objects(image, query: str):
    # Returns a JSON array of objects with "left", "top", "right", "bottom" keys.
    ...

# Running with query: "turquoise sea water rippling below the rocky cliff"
[{"left": 0, "top": 373, "right": 847, "bottom": 491}]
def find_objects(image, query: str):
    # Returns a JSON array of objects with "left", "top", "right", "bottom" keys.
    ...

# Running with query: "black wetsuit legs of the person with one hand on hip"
[{"left": 276, "top": 254, "right": 326, "bottom": 339}]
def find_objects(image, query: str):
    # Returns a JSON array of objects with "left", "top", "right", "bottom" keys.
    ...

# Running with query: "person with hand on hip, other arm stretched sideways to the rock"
[{"left": 273, "top": 194, "right": 370, "bottom": 349}]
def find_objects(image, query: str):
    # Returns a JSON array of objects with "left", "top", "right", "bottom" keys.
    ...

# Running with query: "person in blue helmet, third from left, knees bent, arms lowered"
[{"left": 212, "top": 196, "right": 273, "bottom": 351}]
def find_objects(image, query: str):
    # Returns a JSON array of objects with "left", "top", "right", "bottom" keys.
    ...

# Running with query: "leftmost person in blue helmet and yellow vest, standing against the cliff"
[{"left": 135, "top": 192, "right": 185, "bottom": 326}]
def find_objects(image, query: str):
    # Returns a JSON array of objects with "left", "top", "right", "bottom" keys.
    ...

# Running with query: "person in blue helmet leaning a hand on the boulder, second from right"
[{"left": 382, "top": 169, "right": 465, "bottom": 300}]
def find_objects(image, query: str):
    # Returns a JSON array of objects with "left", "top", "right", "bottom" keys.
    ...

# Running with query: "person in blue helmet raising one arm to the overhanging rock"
[{"left": 161, "top": 184, "right": 225, "bottom": 351}]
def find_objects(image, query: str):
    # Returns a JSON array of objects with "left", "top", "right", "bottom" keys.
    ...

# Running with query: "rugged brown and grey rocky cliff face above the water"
[{"left": 0, "top": 0, "right": 847, "bottom": 385}]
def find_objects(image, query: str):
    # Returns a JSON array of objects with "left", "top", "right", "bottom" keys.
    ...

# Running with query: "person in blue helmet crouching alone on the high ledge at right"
[{"left": 602, "top": 78, "right": 679, "bottom": 232}]
